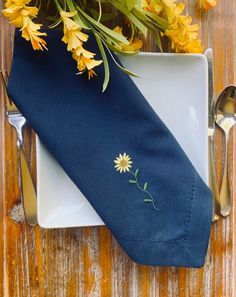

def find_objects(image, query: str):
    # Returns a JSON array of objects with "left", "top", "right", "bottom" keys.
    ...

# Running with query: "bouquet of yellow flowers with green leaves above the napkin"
[{"left": 2, "top": 0, "right": 206, "bottom": 91}]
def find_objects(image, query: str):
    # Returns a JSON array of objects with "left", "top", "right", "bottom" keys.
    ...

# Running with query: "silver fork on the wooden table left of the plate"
[{"left": 0, "top": 70, "right": 37, "bottom": 226}]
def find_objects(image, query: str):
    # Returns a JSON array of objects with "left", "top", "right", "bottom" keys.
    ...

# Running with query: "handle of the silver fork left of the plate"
[{"left": 17, "top": 139, "right": 38, "bottom": 226}]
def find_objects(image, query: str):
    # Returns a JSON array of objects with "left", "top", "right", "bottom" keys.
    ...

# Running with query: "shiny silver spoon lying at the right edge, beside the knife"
[{"left": 215, "top": 86, "right": 236, "bottom": 217}]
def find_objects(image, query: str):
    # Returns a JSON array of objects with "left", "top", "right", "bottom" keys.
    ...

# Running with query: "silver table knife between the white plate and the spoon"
[{"left": 205, "top": 49, "right": 220, "bottom": 222}]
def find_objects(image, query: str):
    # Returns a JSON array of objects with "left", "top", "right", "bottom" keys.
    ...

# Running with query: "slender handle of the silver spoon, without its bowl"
[{"left": 220, "top": 131, "right": 231, "bottom": 217}]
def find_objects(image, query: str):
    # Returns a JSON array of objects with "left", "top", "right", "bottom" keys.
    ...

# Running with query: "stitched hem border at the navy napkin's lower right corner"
[{"left": 117, "top": 171, "right": 212, "bottom": 268}]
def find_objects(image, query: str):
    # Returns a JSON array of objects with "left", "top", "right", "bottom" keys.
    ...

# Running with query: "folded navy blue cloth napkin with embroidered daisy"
[{"left": 8, "top": 31, "right": 212, "bottom": 267}]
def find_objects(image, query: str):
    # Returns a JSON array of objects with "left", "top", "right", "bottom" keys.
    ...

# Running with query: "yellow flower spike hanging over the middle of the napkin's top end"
[{"left": 60, "top": 10, "right": 102, "bottom": 79}]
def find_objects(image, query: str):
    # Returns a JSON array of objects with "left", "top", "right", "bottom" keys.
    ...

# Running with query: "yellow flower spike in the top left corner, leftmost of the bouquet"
[{"left": 2, "top": 0, "right": 47, "bottom": 50}]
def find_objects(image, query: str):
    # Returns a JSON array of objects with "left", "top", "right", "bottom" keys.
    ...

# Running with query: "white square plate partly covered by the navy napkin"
[{"left": 37, "top": 53, "right": 208, "bottom": 228}]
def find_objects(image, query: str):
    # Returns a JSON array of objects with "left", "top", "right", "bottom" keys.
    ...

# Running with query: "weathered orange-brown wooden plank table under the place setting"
[{"left": 0, "top": 0, "right": 236, "bottom": 297}]
